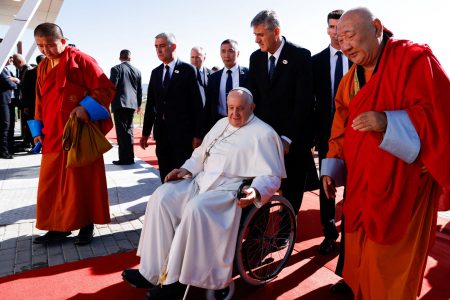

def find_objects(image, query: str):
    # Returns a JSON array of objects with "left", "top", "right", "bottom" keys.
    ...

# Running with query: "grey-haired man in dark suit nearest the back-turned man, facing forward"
[{"left": 140, "top": 33, "right": 203, "bottom": 182}]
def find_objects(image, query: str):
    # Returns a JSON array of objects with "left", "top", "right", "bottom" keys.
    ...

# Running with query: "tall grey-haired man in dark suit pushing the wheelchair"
[{"left": 249, "top": 10, "right": 318, "bottom": 213}]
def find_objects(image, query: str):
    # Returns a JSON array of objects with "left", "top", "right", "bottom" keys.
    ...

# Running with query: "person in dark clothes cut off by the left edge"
[{"left": 0, "top": 67, "right": 19, "bottom": 159}]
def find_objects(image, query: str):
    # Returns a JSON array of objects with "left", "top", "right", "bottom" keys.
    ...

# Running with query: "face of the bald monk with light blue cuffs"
[{"left": 337, "top": 13, "right": 382, "bottom": 69}]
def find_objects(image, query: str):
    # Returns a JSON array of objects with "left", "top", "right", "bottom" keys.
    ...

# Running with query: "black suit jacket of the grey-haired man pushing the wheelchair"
[{"left": 249, "top": 37, "right": 313, "bottom": 148}]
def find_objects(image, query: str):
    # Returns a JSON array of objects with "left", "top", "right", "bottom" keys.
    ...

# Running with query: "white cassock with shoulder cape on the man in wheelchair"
[{"left": 137, "top": 115, "right": 286, "bottom": 289}]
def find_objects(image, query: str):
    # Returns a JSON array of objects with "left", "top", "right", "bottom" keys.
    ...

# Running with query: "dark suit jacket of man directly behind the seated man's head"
[{"left": 203, "top": 66, "right": 248, "bottom": 134}]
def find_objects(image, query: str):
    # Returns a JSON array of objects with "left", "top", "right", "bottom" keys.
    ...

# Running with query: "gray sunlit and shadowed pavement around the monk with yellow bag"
[{"left": 0, "top": 145, "right": 160, "bottom": 277}]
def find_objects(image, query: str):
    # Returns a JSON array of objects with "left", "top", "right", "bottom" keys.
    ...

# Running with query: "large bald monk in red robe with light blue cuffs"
[{"left": 321, "top": 8, "right": 450, "bottom": 299}]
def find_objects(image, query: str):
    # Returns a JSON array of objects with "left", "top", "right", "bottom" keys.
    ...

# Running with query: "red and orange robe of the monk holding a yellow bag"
[{"left": 35, "top": 46, "right": 115, "bottom": 231}]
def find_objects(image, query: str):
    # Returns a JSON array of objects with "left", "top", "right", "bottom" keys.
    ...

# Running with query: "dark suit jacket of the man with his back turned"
[{"left": 110, "top": 62, "right": 142, "bottom": 112}]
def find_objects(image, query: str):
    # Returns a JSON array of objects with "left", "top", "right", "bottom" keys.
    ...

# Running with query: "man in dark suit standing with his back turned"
[{"left": 110, "top": 49, "right": 142, "bottom": 165}]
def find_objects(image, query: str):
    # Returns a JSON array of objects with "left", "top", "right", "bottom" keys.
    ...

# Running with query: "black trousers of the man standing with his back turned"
[{"left": 114, "top": 108, "right": 134, "bottom": 162}]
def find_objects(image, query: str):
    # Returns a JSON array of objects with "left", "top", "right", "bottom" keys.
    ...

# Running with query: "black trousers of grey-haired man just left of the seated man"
[{"left": 156, "top": 125, "right": 193, "bottom": 183}]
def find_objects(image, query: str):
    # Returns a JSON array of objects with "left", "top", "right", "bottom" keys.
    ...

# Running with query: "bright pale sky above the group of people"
[{"left": 0, "top": 0, "right": 450, "bottom": 82}]
